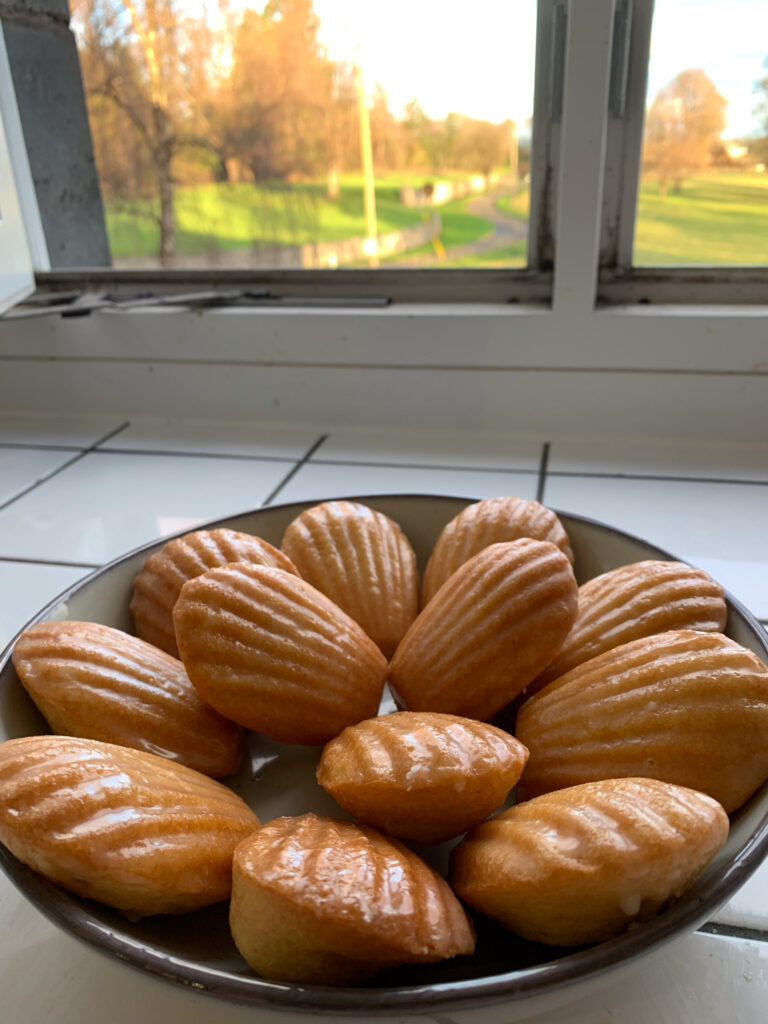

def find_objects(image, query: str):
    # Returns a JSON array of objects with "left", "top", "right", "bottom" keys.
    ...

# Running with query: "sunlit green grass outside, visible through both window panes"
[{"left": 106, "top": 171, "right": 768, "bottom": 266}]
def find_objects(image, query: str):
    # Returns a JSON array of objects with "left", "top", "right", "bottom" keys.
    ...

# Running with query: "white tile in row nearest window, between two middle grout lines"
[{"left": 312, "top": 427, "right": 544, "bottom": 472}]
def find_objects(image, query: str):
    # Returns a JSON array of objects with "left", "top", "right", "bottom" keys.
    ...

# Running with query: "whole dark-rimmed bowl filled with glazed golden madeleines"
[{"left": 0, "top": 495, "right": 768, "bottom": 1022}]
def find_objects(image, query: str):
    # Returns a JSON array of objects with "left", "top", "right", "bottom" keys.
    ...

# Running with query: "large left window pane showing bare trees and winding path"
[{"left": 72, "top": 0, "right": 537, "bottom": 268}]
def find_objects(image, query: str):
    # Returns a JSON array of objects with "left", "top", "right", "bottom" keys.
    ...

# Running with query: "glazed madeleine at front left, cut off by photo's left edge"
[{"left": 0, "top": 736, "right": 258, "bottom": 918}]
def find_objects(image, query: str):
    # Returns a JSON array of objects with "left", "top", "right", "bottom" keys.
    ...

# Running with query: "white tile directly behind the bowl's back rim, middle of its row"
[{"left": 274, "top": 462, "right": 538, "bottom": 503}]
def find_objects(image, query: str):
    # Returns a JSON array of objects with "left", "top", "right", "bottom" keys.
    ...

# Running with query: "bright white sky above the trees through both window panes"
[{"left": 314, "top": 0, "right": 768, "bottom": 138}]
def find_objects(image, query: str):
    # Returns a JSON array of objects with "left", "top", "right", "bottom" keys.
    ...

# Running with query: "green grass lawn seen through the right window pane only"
[{"left": 634, "top": 171, "right": 768, "bottom": 266}]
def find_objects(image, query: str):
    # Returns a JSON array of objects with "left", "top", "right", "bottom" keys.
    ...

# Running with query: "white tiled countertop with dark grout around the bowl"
[{"left": 0, "top": 415, "right": 768, "bottom": 1024}]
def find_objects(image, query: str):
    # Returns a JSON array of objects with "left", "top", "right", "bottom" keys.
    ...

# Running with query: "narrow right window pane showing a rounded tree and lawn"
[{"left": 634, "top": 0, "right": 768, "bottom": 265}]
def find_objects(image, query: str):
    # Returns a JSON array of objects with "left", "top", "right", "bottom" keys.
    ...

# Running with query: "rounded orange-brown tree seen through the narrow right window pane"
[{"left": 643, "top": 69, "right": 728, "bottom": 195}]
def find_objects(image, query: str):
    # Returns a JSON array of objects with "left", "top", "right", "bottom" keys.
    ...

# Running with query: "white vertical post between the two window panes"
[{"left": 553, "top": 0, "right": 615, "bottom": 312}]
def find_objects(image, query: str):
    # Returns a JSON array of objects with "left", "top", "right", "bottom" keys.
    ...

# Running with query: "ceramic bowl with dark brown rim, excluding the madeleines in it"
[{"left": 0, "top": 496, "right": 768, "bottom": 1024}]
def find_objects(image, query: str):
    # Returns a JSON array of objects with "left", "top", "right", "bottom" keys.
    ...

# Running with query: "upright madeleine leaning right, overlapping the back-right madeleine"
[{"left": 389, "top": 538, "right": 578, "bottom": 720}]
